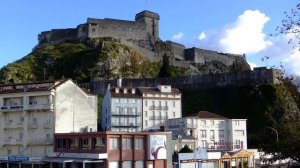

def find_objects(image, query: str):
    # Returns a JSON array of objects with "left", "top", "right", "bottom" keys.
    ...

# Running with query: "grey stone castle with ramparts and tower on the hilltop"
[{"left": 37, "top": 11, "right": 250, "bottom": 71}]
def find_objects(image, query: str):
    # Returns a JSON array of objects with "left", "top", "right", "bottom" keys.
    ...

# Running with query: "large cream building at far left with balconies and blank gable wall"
[{"left": 0, "top": 80, "right": 97, "bottom": 162}]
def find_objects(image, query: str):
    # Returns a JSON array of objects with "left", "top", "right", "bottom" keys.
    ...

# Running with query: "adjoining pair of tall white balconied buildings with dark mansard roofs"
[{"left": 101, "top": 82, "right": 181, "bottom": 131}]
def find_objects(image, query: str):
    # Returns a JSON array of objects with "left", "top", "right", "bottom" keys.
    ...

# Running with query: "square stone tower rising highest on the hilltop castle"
[{"left": 135, "top": 10, "right": 159, "bottom": 38}]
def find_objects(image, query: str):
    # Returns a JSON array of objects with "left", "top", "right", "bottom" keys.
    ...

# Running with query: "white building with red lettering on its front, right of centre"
[{"left": 167, "top": 111, "right": 247, "bottom": 151}]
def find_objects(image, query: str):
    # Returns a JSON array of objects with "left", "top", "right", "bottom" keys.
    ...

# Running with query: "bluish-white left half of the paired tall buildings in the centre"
[{"left": 101, "top": 85, "right": 142, "bottom": 132}]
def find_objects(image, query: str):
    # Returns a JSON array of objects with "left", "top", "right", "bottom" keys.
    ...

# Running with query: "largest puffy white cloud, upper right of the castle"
[{"left": 200, "top": 10, "right": 272, "bottom": 54}]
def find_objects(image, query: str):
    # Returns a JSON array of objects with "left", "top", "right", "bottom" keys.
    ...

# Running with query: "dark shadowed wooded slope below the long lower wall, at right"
[{"left": 181, "top": 81, "right": 300, "bottom": 159}]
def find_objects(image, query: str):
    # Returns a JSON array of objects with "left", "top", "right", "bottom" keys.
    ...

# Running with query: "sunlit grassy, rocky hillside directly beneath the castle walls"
[{"left": 0, "top": 41, "right": 185, "bottom": 83}]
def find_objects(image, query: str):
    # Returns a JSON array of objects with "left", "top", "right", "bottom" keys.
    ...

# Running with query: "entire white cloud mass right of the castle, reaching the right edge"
[{"left": 196, "top": 10, "right": 300, "bottom": 75}]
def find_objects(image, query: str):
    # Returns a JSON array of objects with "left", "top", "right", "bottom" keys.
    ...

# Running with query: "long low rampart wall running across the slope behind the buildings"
[{"left": 79, "top": 67, "right": 282, "bottom": 94}]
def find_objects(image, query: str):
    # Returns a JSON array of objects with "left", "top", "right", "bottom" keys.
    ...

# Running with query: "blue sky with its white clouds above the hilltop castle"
[{"left": 0, "top": 0, "right": 300, "bottom": 74}]
